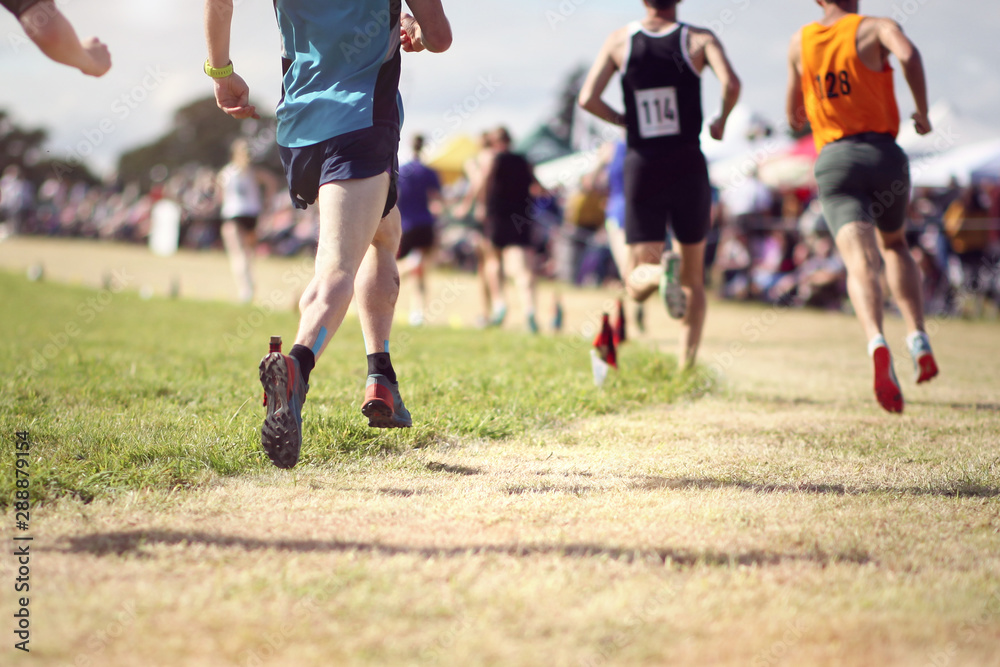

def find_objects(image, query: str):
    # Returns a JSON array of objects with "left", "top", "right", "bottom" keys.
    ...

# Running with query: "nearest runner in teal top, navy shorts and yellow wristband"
[{"left": 205, "top": 0, "right": 451, "bottom": 468}]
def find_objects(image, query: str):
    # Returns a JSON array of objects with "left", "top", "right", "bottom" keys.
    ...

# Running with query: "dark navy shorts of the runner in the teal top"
[{"left": 278, "top": 125, "right": 399, "bottom": 218}]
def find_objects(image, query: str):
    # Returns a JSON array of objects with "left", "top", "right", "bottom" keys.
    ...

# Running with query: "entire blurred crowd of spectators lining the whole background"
[{"left": 0, "top": 141, "right": 1000, "bottom": 315}]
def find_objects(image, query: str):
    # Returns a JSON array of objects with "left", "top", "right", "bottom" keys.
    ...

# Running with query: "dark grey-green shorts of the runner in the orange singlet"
[{"left": 815, "top": 132, "right": 910, "bottom": 239}]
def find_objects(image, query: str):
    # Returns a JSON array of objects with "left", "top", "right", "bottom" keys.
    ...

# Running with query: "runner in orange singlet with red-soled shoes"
[{"left": 787, "top": 0, "right": 938, "bottom": 412}]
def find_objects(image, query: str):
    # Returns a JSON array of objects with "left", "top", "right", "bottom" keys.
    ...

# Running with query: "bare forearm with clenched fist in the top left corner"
[{"left": 21, "top": 2, "right": 111, "bottom": 76}]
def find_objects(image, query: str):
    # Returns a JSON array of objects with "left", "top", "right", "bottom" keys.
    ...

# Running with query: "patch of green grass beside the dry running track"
[{"left": 0, "top": 273, "right": 711, "bottom": 506}]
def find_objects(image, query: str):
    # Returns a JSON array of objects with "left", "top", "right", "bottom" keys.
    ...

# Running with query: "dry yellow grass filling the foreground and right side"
[{"left": 0, "top": 237, "right": 1000, "bottom": 667}]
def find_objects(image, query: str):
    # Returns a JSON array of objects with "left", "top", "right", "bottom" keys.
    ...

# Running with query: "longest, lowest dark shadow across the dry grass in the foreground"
[{"left": 50, "top": 530, "right": 873, "bottom": 567}]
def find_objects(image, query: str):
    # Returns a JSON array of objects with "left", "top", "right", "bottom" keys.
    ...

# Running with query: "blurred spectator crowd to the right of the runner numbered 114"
[{"left": 709, "top": 176, "right": 1000, "bottom": 315}]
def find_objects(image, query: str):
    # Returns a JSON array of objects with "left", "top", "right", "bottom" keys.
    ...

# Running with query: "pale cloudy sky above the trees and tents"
[{"left": 0, "top": 0, "right": 1000, "bottom": 173}]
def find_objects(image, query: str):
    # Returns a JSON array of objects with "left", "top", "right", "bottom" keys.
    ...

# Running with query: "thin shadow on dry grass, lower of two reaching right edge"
[{"left": 632, "top": 475, "right": 1000, "bottom": 498}]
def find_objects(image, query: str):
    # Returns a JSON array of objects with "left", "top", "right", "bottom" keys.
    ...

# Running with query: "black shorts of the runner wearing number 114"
[{"left": 625, "top": 145, "right": 712, "bottom": 245}]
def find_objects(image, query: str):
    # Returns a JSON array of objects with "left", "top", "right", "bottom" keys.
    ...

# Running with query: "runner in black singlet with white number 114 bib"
[{"left": 580, "top": 0, "right": 740, "bottom": 366}]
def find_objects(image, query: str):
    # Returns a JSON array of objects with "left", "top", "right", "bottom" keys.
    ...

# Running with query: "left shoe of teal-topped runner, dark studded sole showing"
[{"left": 260, "top": 352, "right": 309, "bottom": 468}]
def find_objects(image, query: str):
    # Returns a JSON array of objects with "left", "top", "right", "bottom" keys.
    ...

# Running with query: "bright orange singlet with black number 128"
[{"left": 802, "top": 14, "right": 899, "bottom": 152}]
